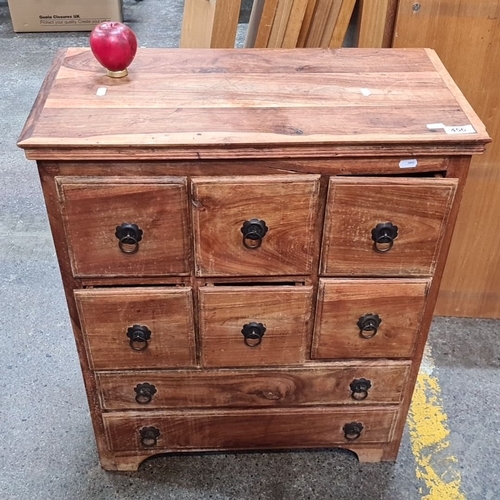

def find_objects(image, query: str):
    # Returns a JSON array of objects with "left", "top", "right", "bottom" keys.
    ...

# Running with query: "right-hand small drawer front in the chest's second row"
[{"left": 311, "top": 279, "right": 430, "bottom": 359}]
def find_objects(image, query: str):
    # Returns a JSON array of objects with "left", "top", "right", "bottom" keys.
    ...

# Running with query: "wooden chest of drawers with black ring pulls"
[{"left": 19, "top": 49, "right": 489, "bottom": 470}]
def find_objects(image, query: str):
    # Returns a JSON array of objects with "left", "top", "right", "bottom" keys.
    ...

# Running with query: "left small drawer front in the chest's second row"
[{"left": 74, "top": 288, "right": 195, "bottom": 370}]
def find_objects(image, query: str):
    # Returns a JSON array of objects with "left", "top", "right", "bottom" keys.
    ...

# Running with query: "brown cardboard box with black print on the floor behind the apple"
[{"left": 9, "top": 0, "right": 122, "bottom": 33}]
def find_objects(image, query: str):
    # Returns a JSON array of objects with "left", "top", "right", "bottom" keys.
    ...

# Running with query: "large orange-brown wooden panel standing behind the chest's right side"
[{"left": 394, "top": 0, "right": 500, "bottom": 318}]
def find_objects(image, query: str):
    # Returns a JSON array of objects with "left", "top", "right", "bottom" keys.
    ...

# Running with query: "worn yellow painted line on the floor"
[{"left": 408, "top": 347, "right": 466, "bottom": 500}]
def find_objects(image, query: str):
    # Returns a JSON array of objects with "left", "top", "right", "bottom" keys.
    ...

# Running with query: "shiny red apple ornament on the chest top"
[{"left": 90, "top": 22, "right": 137, "bottom": 78}]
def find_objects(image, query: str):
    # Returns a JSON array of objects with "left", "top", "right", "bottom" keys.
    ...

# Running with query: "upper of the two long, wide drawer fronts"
[{"left": 97, "top": 361, "right": 410, "bottom": 410}]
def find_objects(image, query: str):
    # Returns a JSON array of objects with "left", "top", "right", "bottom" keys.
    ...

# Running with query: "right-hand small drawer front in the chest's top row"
[{"left": 321, "top": 178, "right": 457, "bottom": 276}]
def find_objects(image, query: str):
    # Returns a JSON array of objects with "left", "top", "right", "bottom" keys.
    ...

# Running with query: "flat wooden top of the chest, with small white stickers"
[{"left": 18, "top": 48, "right": 490, "bottom": 159}]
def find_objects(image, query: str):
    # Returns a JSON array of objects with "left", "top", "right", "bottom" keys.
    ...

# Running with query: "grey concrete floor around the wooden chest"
[{"left": 0, "top": 0, "right": 500, "bottom": 500}]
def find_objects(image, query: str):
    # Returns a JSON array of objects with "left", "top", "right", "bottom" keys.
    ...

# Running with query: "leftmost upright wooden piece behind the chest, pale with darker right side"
[{"left": 180, "top": 0, "right": 241, "bottom": 48}]
